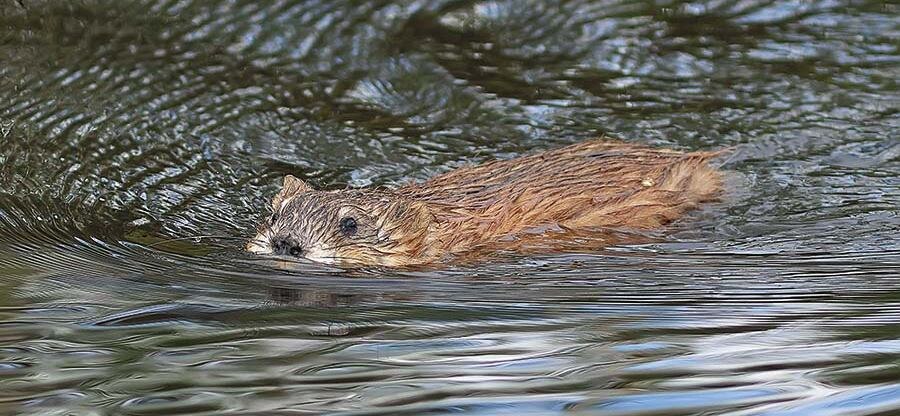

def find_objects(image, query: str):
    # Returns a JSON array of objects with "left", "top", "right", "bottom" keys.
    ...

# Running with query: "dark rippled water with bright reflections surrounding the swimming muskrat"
[{"left": 0, "top": 0, "right": 900, "bottom": 415}]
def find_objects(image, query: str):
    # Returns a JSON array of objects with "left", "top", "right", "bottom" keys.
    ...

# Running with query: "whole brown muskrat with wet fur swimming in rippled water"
[{"left": 246, "top": 140, "right": 722, "bottom": 266}]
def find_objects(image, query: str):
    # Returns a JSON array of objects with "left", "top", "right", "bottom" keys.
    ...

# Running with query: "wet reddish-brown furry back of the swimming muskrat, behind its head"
[{"left": 398, "top": 140, "right": 721, "bottom": 251}]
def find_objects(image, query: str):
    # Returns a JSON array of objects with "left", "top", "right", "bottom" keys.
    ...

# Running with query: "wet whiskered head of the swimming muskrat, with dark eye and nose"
[{"left": 247, "top": 175, "right": 433, "bottom": 266}]
